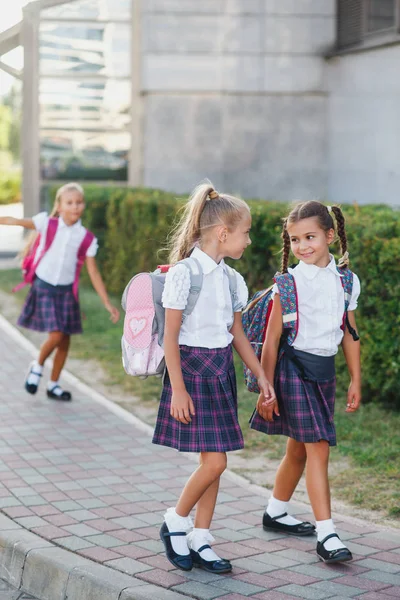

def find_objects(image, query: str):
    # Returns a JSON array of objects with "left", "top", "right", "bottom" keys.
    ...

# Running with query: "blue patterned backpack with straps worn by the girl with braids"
[{"left": 242, "top": 267, "right": 359, "bottom": 394}]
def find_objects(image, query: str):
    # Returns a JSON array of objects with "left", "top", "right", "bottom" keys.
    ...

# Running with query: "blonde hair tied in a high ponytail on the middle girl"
[{"left": 169, "top": 182, "right": 250, "bottom": 264}]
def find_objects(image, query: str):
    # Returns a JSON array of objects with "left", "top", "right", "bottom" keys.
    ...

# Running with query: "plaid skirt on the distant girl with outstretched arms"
[{"left": 17, "top": 277, "right": 82, "bottom": 335}]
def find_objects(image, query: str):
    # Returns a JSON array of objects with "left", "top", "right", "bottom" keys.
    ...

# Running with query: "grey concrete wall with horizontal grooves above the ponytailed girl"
[{"left": 141, "top": 0, "right": 335, "bottom": 200}]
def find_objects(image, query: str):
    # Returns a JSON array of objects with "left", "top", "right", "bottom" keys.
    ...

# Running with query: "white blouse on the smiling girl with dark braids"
[{"left": 273, "top": 255, "right": 360, "bottom": 356}]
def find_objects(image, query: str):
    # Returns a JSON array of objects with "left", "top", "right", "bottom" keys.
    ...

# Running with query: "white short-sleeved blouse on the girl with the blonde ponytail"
[{"left": 162, "top": 247, "right": 248, "bottom": 348}]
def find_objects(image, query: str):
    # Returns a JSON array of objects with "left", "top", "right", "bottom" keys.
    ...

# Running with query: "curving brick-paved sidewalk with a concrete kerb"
[{"left": 0, "top": 318, "right": 400, "bottom": 600}]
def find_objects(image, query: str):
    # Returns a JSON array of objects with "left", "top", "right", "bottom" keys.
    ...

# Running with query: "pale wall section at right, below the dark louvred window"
[{"left": 326, "top": 45, "right": 400, "bottom": 206}]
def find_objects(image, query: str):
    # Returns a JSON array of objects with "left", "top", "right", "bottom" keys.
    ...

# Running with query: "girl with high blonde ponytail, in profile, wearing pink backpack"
[{"left": 153, "top": 183, "right": 275, "bottom": 573}]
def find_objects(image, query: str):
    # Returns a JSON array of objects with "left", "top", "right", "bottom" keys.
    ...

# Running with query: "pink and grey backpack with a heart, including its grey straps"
[{"left": 121, "top": 257, "right": 237, "bottom": 379}]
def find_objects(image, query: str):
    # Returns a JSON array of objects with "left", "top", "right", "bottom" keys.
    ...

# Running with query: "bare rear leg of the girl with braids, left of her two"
[{"left": 273, "top": 438, "right": 307, "bottom": 502}]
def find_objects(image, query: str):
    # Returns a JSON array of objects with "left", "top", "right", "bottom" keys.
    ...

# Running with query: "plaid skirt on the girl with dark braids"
[{"left": 250, "top": 354, "right": 336, "bottom": 446}]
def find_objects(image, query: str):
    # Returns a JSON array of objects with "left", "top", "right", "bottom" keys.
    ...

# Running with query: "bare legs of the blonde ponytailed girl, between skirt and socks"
[{"left": 175, "top": 452, "right": 226, "bottom": 516}]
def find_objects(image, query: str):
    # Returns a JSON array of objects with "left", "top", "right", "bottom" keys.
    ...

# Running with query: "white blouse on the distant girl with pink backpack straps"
[{"left": 32, "top": 212, "right": 98, "bottom": 285}]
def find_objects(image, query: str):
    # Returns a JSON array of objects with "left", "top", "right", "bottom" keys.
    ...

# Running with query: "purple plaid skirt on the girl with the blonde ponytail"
[{"left": 153, "top": 345, "right": 244, "bottom": 452}]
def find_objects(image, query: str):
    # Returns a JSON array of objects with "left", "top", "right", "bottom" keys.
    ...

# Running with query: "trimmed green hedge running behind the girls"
[{"left": 45, "top": 186, "right": 400, "bottom": 408}]
